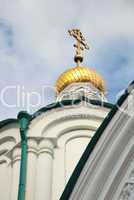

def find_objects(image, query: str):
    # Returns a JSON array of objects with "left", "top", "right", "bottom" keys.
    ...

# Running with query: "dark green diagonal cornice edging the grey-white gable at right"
[{"left": 60, "top": 81, "right": 134, "bottom": 200}]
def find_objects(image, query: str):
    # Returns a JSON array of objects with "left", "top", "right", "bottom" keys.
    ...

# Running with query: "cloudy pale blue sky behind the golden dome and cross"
[{"left": 0, "top": 0, "right": 134, "bottom": 120}]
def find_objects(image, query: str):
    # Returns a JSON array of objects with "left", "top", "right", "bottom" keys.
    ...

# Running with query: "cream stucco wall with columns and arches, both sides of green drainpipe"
[{"left": 0, "top": 103, "right": 109, "bottom": 200}]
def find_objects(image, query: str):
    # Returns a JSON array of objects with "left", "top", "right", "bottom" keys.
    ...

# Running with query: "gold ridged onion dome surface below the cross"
[{"left": 56, "top": 66, "right": 105, "bottom": 93}]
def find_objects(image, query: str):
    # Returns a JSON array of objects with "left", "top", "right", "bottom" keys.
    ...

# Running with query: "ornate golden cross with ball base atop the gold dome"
[{"left": 68, "top": 29, "right": 89, "bottom": 66}]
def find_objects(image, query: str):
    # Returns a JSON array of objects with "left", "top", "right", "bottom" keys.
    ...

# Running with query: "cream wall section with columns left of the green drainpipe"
[{"left": 0, "top": 124, "right": 20, "bottom": 200}]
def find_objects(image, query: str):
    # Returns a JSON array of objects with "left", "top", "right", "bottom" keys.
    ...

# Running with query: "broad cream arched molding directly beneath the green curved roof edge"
[{"left": 28, "top": 101, "right": 109, "bottom": 141}]
